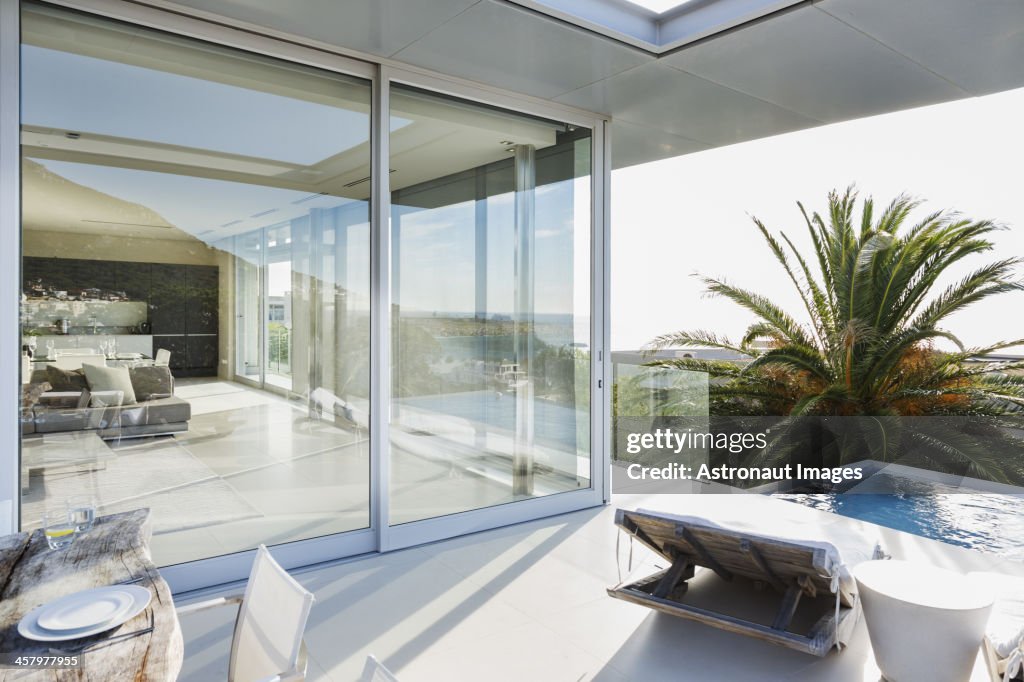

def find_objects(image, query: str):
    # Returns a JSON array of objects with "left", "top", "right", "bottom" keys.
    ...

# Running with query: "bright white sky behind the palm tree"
[{"left": 611, "top": 84, "right": 1024, "bottom": 352}]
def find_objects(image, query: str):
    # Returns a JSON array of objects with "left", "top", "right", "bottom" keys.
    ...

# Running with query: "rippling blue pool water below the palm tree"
[{"left": 773, "top": 479, "right": 1024, "bottom": 561}]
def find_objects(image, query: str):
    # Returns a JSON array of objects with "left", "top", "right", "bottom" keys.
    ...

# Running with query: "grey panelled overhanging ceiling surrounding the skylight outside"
[{"left": 155, "top": 0, "right": 1024, "bottom": 167}]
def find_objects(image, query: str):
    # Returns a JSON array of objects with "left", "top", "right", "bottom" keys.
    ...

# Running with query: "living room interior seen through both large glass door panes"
[{"left": 22, "top": 4, "right": 592, "bottom": 566}]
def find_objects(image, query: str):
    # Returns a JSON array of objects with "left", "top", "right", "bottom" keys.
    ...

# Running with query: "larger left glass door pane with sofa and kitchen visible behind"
[{"left": 22, "top": 4, "right": 370, "bottom": 564}]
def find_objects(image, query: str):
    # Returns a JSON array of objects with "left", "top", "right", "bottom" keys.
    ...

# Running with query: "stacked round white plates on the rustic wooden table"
[{"left": 17, "top": 585, "right": 152, "bottom": 642}]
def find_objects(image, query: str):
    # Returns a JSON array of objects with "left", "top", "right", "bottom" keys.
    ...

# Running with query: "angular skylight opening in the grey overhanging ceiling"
[{"left": 511, "top": 0, "right": 803, "bottom": 54}]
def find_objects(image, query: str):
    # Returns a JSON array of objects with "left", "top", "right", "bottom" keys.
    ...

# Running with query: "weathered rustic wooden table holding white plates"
[{"left": 0, "top": 509, "right": 184, "bottom": 682}]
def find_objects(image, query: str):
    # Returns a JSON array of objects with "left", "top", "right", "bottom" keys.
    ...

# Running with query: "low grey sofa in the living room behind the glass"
[{"left": 22, "top": 367, "right": 191, "bottom": 440}]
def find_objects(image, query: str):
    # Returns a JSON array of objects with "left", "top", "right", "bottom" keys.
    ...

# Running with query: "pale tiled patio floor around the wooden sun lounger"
[{"left": 179, "top": 495, "right": 1024, "bottom": 682}]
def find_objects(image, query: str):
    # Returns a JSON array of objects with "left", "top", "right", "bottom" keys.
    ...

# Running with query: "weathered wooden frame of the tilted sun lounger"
[{"left": 608, "top": 509, "right": 857, "bottom": 656}]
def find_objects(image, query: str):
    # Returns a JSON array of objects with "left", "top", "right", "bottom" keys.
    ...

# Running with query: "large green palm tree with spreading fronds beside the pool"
[{"left": 649, "top": 187, "right": 1024, "bottom": 480}]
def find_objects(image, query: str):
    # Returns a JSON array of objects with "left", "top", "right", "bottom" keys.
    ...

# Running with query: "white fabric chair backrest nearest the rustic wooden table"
[{"left": 228, "top": 545, "right": 313, "bottom": 682}]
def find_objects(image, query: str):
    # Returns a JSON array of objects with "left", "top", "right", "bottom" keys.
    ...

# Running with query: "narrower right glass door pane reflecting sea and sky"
[{"left": 390, "top": 87, "right": 591, "bottom": 523}]
